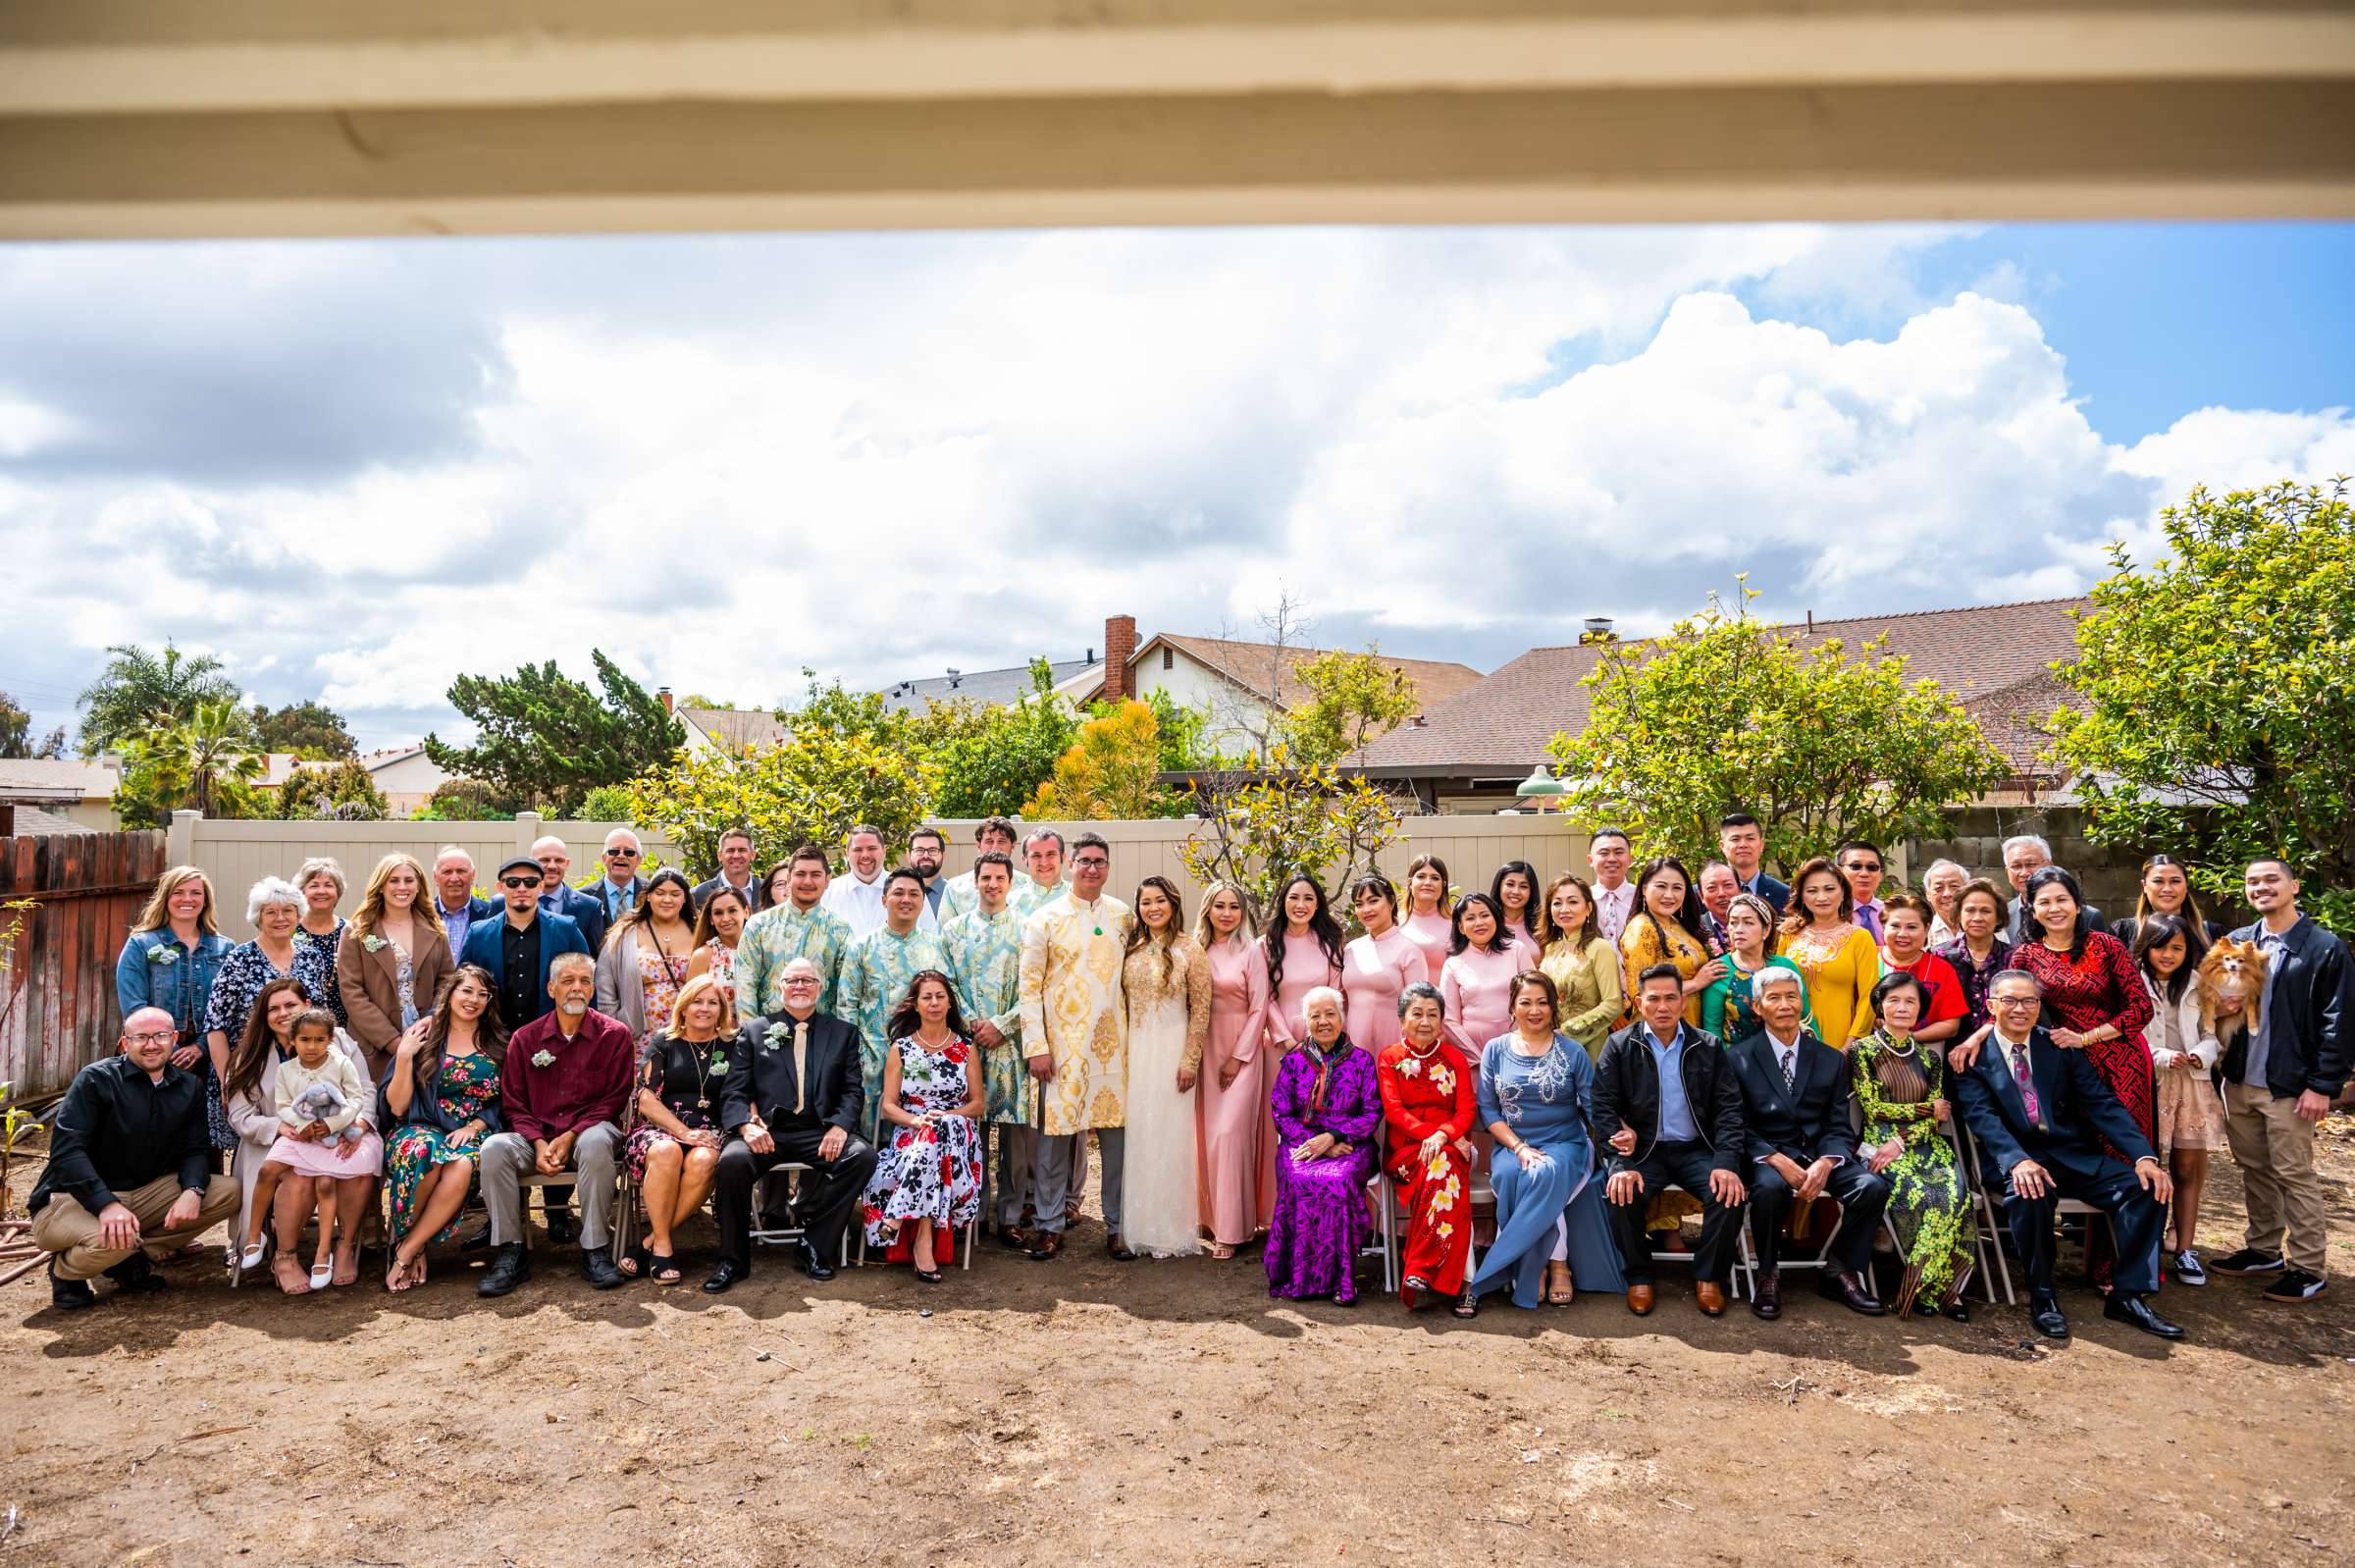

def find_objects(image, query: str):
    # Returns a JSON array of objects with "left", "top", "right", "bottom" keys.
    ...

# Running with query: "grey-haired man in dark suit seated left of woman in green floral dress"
[{"left": 1726, "top": 966, "right": 1889, "bottom": 1319}]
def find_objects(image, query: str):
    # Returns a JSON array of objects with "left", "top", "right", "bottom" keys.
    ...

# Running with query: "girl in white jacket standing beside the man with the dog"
[{"left": 2133, "top": 914, "right": 2224, "bottom": 1285}]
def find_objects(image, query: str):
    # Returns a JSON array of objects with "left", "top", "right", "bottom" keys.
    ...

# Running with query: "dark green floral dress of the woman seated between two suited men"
[{"left": 1849, "top": 1029, "right": 1978, "bottom": 1311}]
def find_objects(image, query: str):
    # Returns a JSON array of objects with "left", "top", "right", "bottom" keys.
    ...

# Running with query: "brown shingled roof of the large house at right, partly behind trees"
[{"left": 1352, "top": 598, "right": 2091, "bottom": 777}]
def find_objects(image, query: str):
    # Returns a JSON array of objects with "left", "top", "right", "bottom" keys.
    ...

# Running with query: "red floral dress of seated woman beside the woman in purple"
[{"left": 1373, "top": 1041, "right": 1479, "bottom": 1307}]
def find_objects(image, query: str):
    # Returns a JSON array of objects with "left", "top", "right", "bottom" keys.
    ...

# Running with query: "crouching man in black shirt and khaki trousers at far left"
[{"left": 26, "top": 1008, "right": 237, "bottom": 1311}]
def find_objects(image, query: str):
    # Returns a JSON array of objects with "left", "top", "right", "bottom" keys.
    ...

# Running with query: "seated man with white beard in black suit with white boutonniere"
[{"left": 705, "top": 959, "right": 876, "bottom": 1295}]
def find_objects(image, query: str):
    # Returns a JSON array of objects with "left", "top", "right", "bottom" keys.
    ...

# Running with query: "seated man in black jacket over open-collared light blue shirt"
[{"left": 1595, "top": 963, "right": 1743, "bottom": 1319}]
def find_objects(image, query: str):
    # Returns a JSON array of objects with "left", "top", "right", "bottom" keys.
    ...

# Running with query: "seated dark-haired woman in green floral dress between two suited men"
[{"left": 1849, "top": 970, "right": 1978, "bottom": 1323}]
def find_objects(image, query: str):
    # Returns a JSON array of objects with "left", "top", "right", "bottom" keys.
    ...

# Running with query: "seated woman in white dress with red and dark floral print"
[{"left": 860, "top": 970, "right": 984, "bottom": 1285}]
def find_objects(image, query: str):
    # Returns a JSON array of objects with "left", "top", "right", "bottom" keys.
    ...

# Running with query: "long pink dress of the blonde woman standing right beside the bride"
[{"left": 1194, "top": 937, "right": 1274, "bottom": 1245}]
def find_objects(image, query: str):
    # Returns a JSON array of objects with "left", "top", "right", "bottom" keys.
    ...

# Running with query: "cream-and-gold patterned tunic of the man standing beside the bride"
[{"left": 1020, "top": 892, "right": 1135, "bottom": 1137}]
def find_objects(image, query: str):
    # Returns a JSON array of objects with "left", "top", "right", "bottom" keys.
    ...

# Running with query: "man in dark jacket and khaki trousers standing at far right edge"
[{"left": 2209, "top": 860, "right": 2355, "bottom": 1302}]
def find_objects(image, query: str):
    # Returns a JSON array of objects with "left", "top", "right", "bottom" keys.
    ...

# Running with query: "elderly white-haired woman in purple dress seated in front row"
[{"left": 1267, "top": 986, "right": 1383, "bottom": 1307}]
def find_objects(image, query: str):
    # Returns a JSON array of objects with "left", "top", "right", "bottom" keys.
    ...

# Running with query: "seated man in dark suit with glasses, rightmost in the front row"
[{"left": 1955, "top": 970, "right": 2183, "bottom": 1339}]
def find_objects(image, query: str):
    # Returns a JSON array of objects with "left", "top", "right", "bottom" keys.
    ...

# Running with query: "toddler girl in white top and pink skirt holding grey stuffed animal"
[{"left": 242, "top": 1008, "right": 384, "bottom": 1290}]
